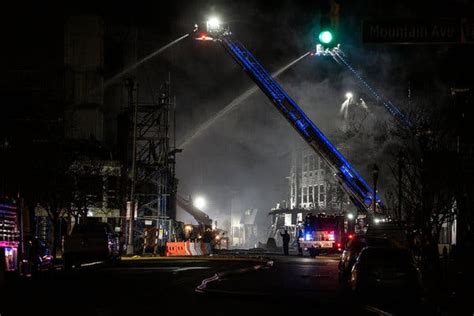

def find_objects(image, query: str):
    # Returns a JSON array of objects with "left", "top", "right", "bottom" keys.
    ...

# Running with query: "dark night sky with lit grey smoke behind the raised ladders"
[{"left": 0, "top": 1, "right": 473, "bottom": 221}]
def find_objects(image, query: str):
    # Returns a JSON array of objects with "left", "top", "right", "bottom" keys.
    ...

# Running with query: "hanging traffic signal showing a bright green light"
[{"left": 318, "top": 0, "right": 340, "bottom": 48}]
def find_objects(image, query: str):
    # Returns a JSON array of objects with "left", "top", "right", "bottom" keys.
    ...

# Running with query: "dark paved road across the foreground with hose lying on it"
[{"left": 0, "top": 256, "right": 422, "bottom": 316}]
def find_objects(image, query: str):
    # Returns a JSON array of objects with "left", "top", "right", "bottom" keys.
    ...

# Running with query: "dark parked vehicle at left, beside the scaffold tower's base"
[{"left": 63, "top": 222, "right": 120, "bottom": 269}]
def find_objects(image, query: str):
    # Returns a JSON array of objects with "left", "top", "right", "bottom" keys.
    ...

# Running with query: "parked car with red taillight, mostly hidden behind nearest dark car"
[{"left": 339, "top": 235, "right": 395, "bottom": 282}]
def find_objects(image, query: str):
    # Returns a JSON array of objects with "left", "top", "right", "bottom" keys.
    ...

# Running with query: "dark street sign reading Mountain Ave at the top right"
[{"left": 362, "top": 19, "right": 474, "bottom": 44}]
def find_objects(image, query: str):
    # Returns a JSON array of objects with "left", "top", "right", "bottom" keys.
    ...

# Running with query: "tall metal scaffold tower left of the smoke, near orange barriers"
[{"left": 127, "top": 80, "right": 179, "bottom": 254}]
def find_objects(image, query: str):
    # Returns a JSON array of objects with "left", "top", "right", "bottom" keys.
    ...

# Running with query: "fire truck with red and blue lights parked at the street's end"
[{"left": 299, "top": 213, "right": 345, "bottom": 257}]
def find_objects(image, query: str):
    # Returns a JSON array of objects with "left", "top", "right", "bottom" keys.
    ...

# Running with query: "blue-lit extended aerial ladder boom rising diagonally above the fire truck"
[{"left": 218, "top": 36, "right": 382, "bottom": 212}]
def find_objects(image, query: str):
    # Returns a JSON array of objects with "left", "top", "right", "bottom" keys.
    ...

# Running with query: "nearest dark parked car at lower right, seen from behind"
[{"left": 350, "top": 247, "right": 421, "bottom": 300}]
